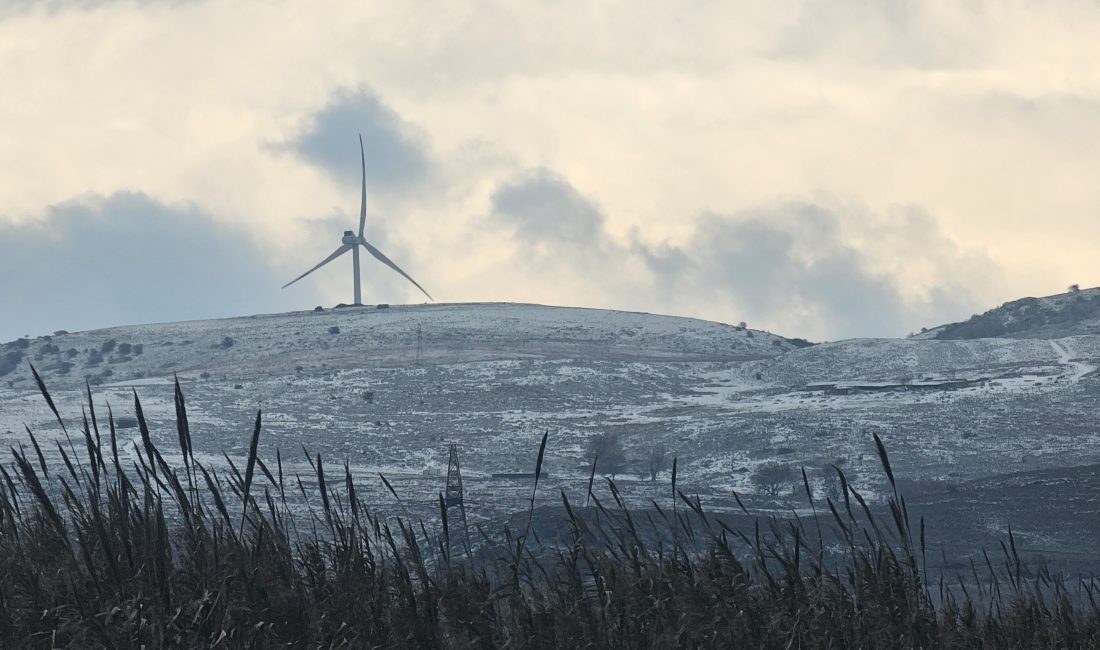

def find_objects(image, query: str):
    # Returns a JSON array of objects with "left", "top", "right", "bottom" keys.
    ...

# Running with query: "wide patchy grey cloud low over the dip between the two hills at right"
[{"left": 636, "top": 201, "right": 994, "bottom": 339}]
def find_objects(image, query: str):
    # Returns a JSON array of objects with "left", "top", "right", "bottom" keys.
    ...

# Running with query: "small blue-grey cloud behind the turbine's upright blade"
[{"left": 281, "top": 88, "right": 431, "bottom": 191}]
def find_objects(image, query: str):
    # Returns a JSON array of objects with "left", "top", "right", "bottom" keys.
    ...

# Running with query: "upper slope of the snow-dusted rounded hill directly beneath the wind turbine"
[{"left": 0, "top": 304, "right": 798, "bottom": 387}]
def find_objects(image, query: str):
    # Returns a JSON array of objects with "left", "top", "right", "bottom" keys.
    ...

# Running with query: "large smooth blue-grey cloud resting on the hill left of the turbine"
[{"left": 0, "top": 192, "right": 304, "bottom": 341}]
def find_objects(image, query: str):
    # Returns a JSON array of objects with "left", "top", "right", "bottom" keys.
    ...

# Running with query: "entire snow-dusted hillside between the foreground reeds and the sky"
[{"left": 0, "top": 301, "right": 1100, "bottom": 538}]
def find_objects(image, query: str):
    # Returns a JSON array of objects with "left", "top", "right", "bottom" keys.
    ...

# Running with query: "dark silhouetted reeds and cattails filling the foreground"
[{"left": 0, "top": 372, "right": 1100, "bottom": 648}]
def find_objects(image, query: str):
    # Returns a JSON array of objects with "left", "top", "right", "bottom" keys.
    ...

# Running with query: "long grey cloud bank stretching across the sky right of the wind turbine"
[{"left": 488, "top": 169, "right": 993, "bottom": 339}]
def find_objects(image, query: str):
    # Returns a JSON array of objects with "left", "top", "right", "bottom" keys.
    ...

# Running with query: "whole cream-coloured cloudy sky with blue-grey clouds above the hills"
[{"left": 0, "top": 0, "right": 1100, "bottom": 341}]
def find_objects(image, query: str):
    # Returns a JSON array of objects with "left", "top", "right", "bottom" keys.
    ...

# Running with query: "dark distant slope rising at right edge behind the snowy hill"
[{"left": 914, "top": 288, "right": 1100, "bottom": 340}]
